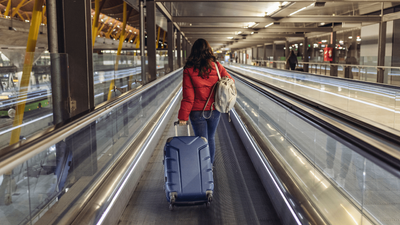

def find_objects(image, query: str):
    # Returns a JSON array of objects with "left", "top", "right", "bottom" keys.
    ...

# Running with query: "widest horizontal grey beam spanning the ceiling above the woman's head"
[{"left": 172, "top": 15, "right": 381, "bottom": 23}]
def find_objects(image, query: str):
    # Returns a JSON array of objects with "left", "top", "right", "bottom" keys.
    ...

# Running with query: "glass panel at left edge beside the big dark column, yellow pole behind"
[{"left": 0, "top": 52, "right": 54, "bottom": 149}]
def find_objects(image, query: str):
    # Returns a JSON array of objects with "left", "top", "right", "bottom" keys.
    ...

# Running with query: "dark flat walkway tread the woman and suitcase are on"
[{"left": 119, "top": 105, "right": 280, "bottom": 225}]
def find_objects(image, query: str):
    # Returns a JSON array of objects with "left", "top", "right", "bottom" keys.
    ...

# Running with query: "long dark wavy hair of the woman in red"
[{"left": 184, "top": 38, "right": 217, "bottom": 79}]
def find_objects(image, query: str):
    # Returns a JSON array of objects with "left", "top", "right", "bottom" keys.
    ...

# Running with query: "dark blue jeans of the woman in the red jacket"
[{"left": 190, "top": 110, "right": 221, "bottom": 163}]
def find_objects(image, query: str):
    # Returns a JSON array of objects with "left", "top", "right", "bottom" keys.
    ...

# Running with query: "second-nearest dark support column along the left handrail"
[{"left": 145, "top": 0, "right": 157, "bottom": 83}]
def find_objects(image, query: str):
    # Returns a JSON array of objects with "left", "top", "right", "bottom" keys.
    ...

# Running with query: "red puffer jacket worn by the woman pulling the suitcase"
[{"left": 178, "top": 62, "right": 232, "bottom": 121}]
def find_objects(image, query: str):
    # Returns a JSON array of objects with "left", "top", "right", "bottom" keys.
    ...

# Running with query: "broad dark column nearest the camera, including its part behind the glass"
[{"left": 47, "top": 0, "right": 97, "bottom": 181}]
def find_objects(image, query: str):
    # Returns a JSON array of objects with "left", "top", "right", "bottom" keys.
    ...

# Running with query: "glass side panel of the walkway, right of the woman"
[{"left": 236, "top": 76, "right": 400, "bottom": 225}]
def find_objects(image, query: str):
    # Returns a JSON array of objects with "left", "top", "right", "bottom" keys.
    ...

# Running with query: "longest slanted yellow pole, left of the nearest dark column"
[{"left": 10, "top": 0, "right": 44, "bottom": 145}]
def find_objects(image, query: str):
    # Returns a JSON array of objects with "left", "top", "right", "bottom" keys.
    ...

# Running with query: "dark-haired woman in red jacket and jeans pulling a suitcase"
[{"left": 178, "top": 39, "right": 232, "bottom": 163}]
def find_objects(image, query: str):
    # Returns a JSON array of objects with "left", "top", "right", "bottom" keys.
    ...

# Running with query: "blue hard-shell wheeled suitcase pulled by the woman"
[{"left": 163, "top": 122, "right": 214, "bottom": 210}]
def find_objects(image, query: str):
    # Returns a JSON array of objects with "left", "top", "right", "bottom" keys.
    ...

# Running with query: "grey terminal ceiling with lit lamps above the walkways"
[{"left": 161, "top": 0, "right": 400, "bottom": 49}]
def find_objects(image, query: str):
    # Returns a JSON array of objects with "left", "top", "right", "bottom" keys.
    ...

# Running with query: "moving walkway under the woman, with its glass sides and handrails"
[{"left": 0, "top": 69, "right": 400, "bottom": 224}]
